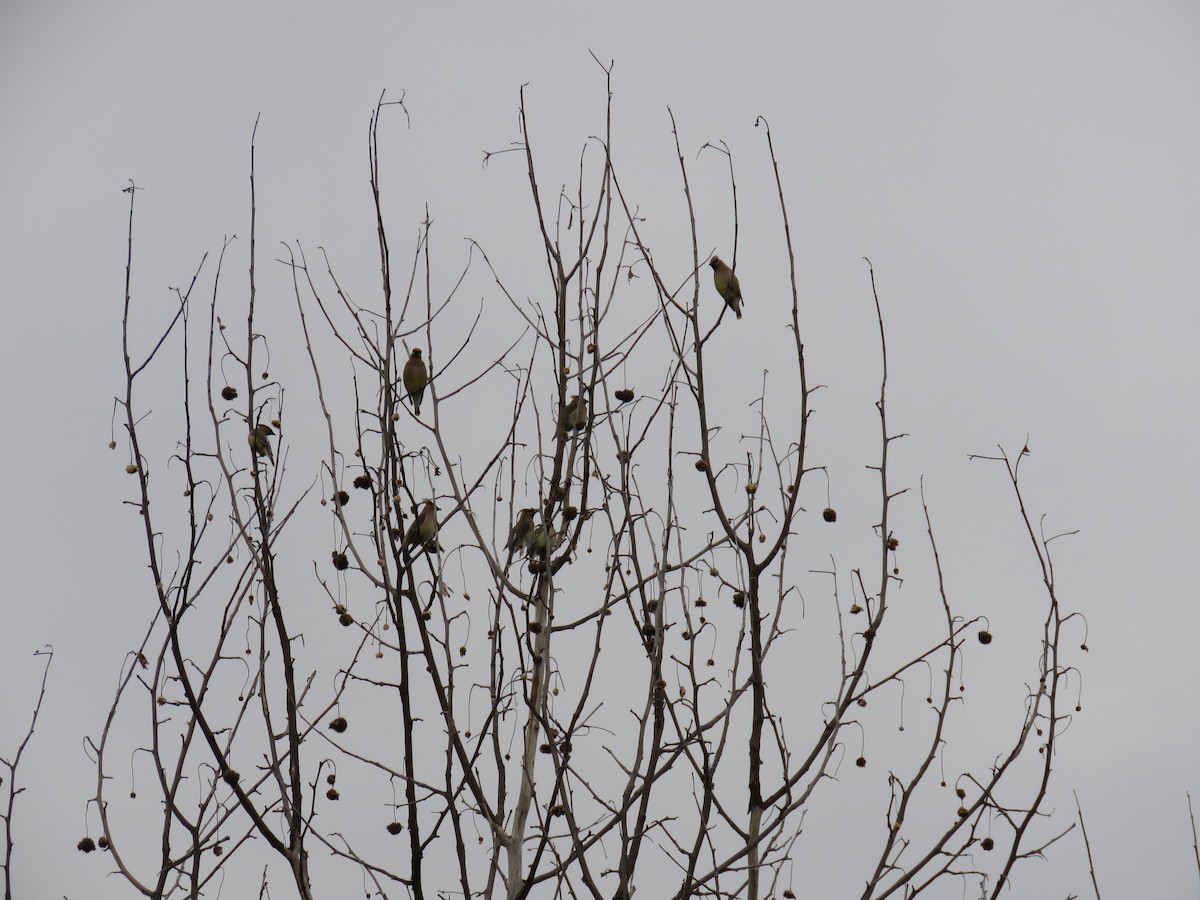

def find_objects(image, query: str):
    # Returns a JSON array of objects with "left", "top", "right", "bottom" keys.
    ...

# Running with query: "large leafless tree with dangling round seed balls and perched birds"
[{"left": 92, "top": 70, "right": 1075, "bottom": 900}]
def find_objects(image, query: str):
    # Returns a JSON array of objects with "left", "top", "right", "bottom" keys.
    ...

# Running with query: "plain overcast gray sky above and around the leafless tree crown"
[{"left": 0, "top": 0, "right": 1200, "bottom": 898}]
